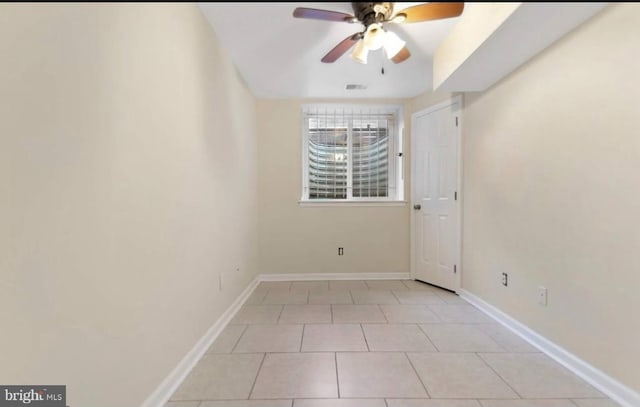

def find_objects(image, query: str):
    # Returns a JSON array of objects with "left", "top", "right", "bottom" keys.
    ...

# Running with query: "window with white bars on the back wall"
[{"left": 302, "top": 105, "right": 402, "bottom": 202}]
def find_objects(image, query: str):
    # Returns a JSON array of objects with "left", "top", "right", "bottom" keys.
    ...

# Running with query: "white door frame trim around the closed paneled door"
[{"left": 409, "top": 95, "right": 464, "bottom": 290}]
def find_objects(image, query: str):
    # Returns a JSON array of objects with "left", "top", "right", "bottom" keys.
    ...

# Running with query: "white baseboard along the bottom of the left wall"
[{"left": 141, "top": 278, "right": 258, "bottom": 407}]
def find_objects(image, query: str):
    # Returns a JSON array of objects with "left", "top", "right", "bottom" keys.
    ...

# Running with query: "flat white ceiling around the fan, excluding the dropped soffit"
[{"left": 199, "top": 2, "right": 459, "bottom": 98}]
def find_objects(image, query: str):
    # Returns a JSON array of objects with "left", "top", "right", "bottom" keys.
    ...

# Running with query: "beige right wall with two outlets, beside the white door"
[{"left": 462, "top": 4, "right": 640, "bottom": 389}]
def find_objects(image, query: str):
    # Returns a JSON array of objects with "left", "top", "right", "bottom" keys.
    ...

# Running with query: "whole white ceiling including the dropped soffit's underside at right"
[{"left": 199, "top": 2, "right": 609, "bottom": 98}]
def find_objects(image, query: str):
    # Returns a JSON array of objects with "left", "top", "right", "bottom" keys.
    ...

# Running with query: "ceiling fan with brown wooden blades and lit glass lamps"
[{"left": 293, "top": 2, "right": 464, "bottom": 64}]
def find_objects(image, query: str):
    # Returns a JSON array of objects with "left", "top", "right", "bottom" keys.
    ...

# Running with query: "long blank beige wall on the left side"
[{"left": 0, "top": 4, "right": 257, "bottom": 407}]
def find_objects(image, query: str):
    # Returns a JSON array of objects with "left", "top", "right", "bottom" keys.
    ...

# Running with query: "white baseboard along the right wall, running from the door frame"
[{"left": 458, "top": 290, "right": 640, "bottom": 407}]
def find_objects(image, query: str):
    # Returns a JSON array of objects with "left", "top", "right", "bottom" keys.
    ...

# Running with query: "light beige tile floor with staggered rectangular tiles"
[{"left": 166, "top": 280, "right": 617, "bottom": 407}]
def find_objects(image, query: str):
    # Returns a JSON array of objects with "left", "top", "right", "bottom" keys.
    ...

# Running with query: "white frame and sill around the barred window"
[{"left": 299, "top": 104, "right": 406, "bottom": 206}]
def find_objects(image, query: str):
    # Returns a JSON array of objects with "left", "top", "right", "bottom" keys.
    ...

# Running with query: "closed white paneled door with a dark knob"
[{"left": 411, "top": 98, "right": 461, "bottom": 291}]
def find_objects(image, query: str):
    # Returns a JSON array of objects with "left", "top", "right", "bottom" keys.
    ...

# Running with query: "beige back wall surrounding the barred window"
[{"left": 257, "top": 100, "right": 409, "bottom": 273}]
